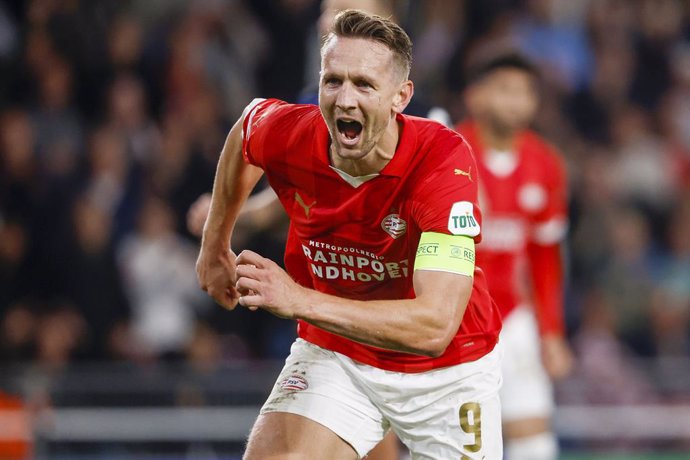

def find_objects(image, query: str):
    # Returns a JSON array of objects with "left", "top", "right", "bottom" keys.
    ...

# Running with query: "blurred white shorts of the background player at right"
[{"left": 500, "top": 307, "right": 553, "bottom": 421}]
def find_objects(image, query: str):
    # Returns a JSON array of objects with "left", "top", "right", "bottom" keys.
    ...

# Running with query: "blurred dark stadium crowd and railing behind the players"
[{"left": 0, "top": 0, "right": 690, "bottom": 459}]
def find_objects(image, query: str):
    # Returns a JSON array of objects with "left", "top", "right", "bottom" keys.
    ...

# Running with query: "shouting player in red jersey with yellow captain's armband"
[{"left": 197, "top": 10, "right": 502, "bottom": 460}]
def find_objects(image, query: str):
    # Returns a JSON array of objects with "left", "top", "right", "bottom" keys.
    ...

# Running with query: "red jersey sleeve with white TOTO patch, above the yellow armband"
[{"left": 412, "top": 141, "right": 482, "bottom": 243}]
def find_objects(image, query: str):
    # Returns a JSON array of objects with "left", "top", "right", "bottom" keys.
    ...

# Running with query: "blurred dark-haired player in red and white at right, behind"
[{"left": 456, "top": 52, "right": 572, "bottom": 460}]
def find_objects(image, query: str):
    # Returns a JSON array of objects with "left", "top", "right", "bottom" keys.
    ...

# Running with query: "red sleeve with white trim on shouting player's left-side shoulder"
[{"left": 242, "top": 99, "right": 285, "bottom": 169}]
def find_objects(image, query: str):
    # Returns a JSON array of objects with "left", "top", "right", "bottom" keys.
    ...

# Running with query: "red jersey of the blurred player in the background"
[{"left": 456, "top": 122, "right": 567, "bottom": 334}]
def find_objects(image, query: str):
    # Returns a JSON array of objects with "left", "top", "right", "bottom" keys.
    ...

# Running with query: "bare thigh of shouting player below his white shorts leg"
[{"left": 244, "top": 412, "right": 358, "bottom": 460}]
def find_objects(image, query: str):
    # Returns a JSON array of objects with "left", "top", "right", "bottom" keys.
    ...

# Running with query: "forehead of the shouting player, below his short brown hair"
[{"left": 321, "top": 36, "right": 393, "bottom": 77}]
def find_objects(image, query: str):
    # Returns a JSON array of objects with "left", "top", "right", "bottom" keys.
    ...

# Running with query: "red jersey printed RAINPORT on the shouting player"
[{"left": 243, "top": 99, "right": 501, "bottom": 372}]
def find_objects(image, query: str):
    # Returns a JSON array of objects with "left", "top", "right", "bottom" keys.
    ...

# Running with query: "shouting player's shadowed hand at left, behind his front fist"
[{"left": 196, "top": 246, "right": 240, "bottom": 310}]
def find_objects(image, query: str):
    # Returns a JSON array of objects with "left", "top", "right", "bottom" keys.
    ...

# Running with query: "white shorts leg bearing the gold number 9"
[{"left": 346, "top": 345, "right": 503, "bottom": 460}]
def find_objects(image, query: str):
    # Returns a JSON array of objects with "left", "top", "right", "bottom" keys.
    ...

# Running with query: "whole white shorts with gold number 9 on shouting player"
[{"left": 261, "top": 339, "right": 503, "bottom": 460}]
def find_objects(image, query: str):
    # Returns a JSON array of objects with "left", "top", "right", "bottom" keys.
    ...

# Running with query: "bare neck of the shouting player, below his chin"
[{"left": 330, "top": 117, "right": 401, "bottom": 177}]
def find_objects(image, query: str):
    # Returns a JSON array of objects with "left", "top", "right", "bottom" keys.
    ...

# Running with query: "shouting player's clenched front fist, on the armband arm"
[{"left": 235, "top": 251, "right": 305, "bottom": 319}]
